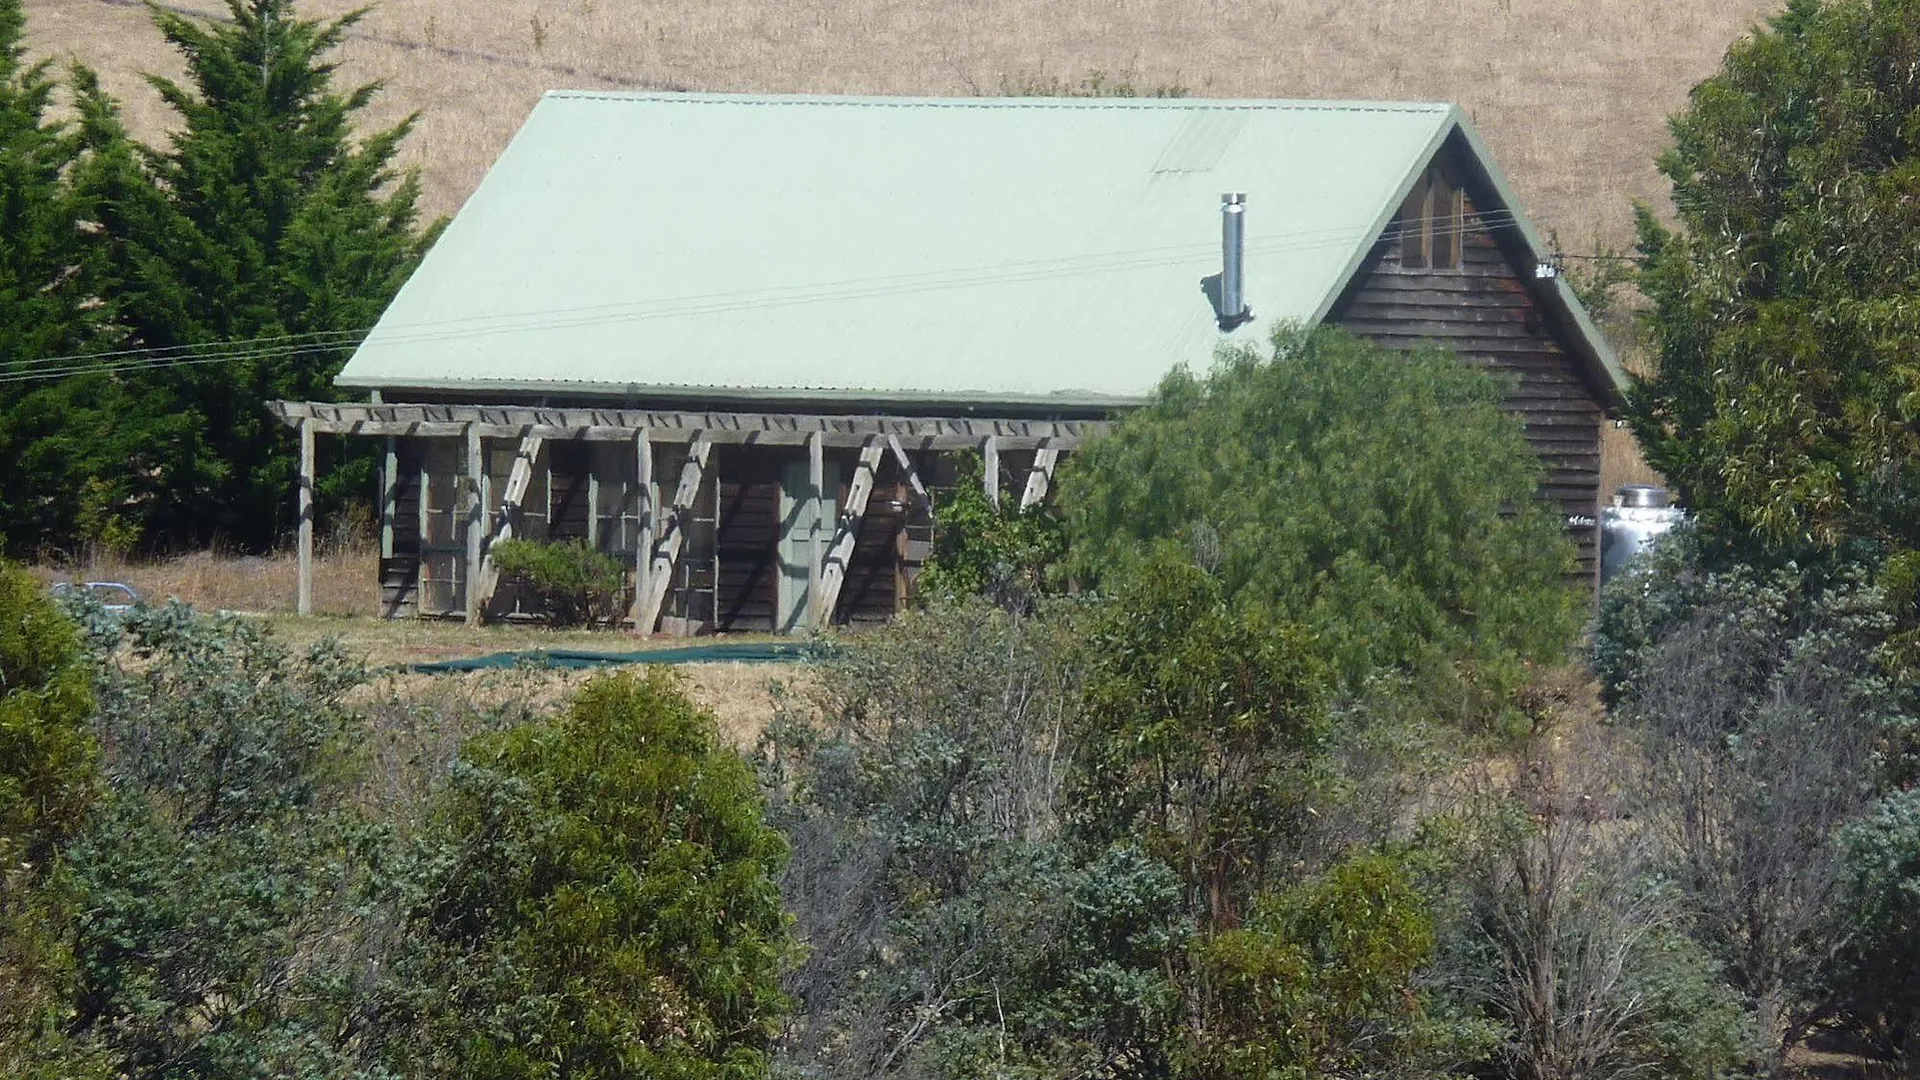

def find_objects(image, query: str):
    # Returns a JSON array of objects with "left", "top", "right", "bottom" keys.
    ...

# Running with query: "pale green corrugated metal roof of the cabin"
[{"left": 340, "top": 92, "right": 1612, "bottom": 405}]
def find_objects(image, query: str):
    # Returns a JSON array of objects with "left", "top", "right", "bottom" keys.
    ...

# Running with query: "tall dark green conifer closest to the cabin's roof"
[{"left": 86, "top": 0, "right": 438, "bottom": 548}]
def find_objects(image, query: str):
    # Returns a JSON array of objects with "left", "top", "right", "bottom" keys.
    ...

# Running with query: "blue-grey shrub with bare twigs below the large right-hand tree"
[{"left": 1594, "top": 534, "right": 1914, "bottom": 1057}]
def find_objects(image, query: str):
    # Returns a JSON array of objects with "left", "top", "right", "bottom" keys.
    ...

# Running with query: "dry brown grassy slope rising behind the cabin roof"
[{"left": 27, "top": 0, "right": 1778, "bottom": 248}]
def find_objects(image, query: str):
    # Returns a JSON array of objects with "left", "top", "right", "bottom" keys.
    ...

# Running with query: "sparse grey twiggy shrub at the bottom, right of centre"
[{"left": 1436, "top": 730, "right": 1755, "bottom": 1080}]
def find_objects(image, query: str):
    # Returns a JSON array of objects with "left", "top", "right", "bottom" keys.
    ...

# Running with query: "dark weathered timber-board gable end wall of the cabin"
[{"left": 1327, "top": 196, "right": 1603, "bottom": 580}]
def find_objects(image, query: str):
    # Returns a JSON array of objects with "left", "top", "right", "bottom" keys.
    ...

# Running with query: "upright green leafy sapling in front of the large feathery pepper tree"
[{"left": 1071, "top": 548, "right": 1327, "bottom": 928}]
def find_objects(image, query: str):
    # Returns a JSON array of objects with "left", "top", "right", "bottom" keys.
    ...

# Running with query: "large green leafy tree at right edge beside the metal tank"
[{"left": 1632, "top": 0, "right": 1920, "bottom": 548}]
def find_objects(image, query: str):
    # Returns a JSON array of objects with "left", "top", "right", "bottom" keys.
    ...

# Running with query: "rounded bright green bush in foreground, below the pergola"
[{"left": 392, "top": 671, "right": 789, "bottom": 1080}]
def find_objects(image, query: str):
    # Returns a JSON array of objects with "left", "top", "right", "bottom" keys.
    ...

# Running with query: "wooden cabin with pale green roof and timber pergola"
[{"left": 273, "top": 92, "right": 1624, "bottom": 632}]
